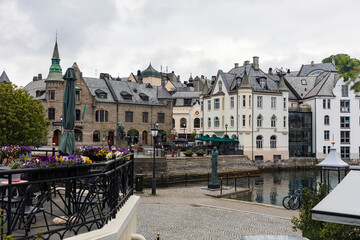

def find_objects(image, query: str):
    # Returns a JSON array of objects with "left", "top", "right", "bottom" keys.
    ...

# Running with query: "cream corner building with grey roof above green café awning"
[{"left": 201, "top": 57, "right": 289, "bottom": 161}]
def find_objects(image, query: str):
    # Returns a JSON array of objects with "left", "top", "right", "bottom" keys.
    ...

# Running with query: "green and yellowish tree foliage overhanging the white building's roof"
[{"left": 322, "top": 53, "right": 360, "bottom": 92}]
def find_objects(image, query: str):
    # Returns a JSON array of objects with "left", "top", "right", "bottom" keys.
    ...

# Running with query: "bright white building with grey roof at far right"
[{"left": 286, "top": 62, "right": 360, "bottom": 159}]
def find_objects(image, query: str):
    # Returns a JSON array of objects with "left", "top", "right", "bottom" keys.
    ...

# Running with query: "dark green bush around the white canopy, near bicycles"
[{"left": 291, "top": 183, "right": 360, "bottom": 240}]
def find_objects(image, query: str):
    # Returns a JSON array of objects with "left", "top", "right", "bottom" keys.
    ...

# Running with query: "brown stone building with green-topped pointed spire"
[{"left": 25, "top": 42, "right": 172, "bottom": 145}]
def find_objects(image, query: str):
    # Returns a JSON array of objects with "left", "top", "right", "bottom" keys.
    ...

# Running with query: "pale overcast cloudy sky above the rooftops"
[{"left": 0, "top": 0, "right": 360, "bottom": 86}]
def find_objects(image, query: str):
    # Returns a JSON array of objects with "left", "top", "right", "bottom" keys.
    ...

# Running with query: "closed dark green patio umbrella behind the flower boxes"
[{"left": 59, "top": 68, "right": 76, "bottom": 155}]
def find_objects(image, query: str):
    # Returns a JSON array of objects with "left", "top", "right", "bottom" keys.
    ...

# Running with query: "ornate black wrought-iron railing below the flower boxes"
[{"left": 0, "top": 154, "right": 134, "bottom": 239}]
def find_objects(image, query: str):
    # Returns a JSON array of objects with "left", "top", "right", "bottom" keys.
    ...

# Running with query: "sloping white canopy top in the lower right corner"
[{"left": 311, "top": 170, "right": 360, "bottom": 226}]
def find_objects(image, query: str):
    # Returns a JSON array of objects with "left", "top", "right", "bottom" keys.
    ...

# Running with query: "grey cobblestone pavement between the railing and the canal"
[{"left": 137, "top": 187, "right": 301, "bottom": 240}]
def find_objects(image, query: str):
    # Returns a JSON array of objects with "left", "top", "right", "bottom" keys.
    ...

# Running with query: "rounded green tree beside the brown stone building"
[{"left": 0, "top": 84, "right": 50, "bottom": 146}]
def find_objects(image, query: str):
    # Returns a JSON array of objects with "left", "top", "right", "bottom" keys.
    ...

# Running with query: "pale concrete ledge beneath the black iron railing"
[{"left": 67, "top": 195, "right": 140, "bottom": 240}]
